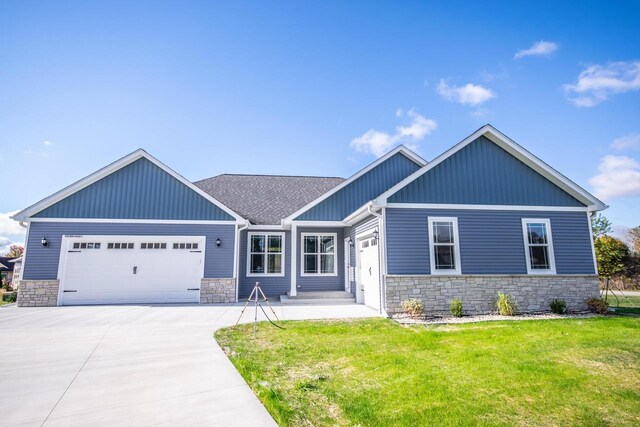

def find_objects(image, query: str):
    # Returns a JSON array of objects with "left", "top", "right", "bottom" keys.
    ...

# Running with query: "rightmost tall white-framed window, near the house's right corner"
[{"left": 522, "top": 218, "right": 556, "bottom": 274}]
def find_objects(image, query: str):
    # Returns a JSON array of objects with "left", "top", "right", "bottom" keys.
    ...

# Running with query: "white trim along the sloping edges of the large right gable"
[{"left": 376, "top": 125, "right": 608, "bottom": 211}]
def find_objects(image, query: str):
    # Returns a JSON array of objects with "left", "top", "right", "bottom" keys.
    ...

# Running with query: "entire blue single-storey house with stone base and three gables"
[{"left": 14, "top": 125, "right": 606, "bottom": 313}]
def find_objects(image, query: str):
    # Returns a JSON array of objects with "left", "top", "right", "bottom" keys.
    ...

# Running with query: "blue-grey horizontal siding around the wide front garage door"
[{"left": 22, "top": 221, "right": 236, "bottom": 280}]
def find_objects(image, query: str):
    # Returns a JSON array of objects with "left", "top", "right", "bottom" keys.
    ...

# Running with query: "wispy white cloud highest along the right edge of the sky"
[{"left": 564, "top": 61, "right": 640, "bottom": 107}]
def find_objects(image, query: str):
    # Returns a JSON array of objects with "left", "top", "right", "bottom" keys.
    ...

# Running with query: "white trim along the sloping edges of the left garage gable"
[{"left": 11, "top": 148, "right": 246, "bottom": 224}]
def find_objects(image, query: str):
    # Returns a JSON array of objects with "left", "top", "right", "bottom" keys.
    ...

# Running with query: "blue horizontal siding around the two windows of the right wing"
[{"left": 386, "top": 208, "right": 595, "bottom": 275}]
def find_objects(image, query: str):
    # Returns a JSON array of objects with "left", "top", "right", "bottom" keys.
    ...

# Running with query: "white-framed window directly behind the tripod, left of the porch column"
[{"left": 247, "top": 233, "right": 284, "bottom": 276}]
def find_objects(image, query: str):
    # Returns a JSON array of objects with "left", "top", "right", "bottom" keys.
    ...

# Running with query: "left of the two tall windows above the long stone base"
[{"left": 428, "top": 217, "right": 461, "bottom": 274}]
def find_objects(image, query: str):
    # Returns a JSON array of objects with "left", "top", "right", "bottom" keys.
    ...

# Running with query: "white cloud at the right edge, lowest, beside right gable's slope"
[{"left": 589, "top": 155, "right": 640, "bottom": 200}]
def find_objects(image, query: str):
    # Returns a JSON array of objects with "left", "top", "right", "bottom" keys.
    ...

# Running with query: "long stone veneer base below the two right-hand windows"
[{"left": 386, "top": 275, "right": 600, "bottom": 314}]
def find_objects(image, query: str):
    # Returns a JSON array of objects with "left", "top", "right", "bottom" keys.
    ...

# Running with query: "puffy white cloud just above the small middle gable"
[{"left": 351, "top": 109, "right": 438, "bottom": 157}]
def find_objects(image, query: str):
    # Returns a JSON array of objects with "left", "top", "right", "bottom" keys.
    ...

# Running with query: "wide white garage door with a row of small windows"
[{"left": 60, "top": 236, "right": 205, "bottom": 304}]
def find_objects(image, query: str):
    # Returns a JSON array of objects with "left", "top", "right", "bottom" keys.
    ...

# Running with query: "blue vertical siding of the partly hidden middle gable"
[{"left": 296, "top": 153, "right": 420, "bottom": 221}]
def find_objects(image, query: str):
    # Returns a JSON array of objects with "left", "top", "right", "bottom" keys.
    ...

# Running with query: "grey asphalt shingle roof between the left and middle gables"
[{"left": 194, "top": 174, "right": 344, "bottom": 225}]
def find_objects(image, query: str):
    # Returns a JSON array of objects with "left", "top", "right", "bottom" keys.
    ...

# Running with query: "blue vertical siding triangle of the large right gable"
[{"left": 388, "top": 136, "right": 584, "bottom": 207}]
